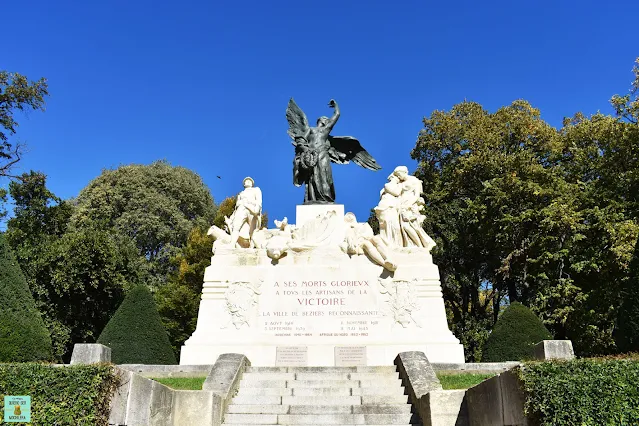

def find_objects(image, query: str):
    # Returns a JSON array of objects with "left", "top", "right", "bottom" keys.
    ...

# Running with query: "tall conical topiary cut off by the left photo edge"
[{"left": 0, "top": 233, "right": 52, "bottom": 362}]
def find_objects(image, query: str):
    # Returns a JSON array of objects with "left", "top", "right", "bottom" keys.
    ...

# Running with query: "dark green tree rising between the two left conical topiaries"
[{"left": 7, "top": 172, "right": 146, "bottom": 360}]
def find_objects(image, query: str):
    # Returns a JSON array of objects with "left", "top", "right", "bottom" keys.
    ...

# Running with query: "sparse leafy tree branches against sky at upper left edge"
[{"left": 0, "top": 71, "right": 49, "bottom": 177}]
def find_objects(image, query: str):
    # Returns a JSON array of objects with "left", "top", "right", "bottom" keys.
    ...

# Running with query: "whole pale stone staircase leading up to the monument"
[{"left": 223, "top": 366, "right": 421, "bottom": 426}]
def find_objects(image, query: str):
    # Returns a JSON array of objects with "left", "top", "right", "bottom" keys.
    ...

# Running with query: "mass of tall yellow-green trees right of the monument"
[{"left": 412, "top": 57, "right": 639, "bottom": 361}]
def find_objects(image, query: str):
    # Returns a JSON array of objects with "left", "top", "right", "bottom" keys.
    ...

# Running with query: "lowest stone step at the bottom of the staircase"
[{"left": 224, "top": 414, "right": 417, "bottom": 425}]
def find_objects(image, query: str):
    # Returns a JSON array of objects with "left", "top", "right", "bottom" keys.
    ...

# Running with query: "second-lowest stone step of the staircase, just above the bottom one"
[{"left": 227, "top": 404, "right": 411, "bottom": 414}]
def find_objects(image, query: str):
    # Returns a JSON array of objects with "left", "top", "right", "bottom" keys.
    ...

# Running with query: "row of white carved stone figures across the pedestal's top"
[{"left": 208, "top": 166, "right": 435, "bottom": 271}]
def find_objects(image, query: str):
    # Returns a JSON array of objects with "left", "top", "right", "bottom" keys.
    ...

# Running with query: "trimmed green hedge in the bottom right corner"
[{"left": 519, "top": 359, "right": 639, "bottom": 426}]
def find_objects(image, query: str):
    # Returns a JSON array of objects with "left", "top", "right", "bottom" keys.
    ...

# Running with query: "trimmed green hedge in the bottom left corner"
[{"left": 0, "top": 363, "right": 119, "bottom": 426}]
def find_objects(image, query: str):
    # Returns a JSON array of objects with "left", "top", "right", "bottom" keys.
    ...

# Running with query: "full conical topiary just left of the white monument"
[{"left": 98, "top": 286, "right": 176, "bottom": 364}]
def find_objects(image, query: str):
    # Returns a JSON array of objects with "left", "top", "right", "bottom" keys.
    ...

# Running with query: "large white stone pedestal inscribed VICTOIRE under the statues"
[{"left": 180, "top": 205, "right": 464, "bottom": 366}]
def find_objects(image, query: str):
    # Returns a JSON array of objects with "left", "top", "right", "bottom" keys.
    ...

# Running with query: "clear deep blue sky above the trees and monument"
[{"left": 0, "top": 0, "right": 639, "bottom": 226}]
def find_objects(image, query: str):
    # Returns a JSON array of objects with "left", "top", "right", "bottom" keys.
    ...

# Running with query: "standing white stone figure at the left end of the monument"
[{"left": 208, "top": 177, "right": 262, "bottom": 250}]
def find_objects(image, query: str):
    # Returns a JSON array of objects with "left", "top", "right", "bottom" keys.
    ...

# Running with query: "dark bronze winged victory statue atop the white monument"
[{"left": 286, "top": 98, "right": 382, "bottom": 204}]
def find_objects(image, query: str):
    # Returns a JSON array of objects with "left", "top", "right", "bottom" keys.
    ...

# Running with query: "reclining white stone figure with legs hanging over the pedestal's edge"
[{"left": 341, "top": 213, "right": 397, "bottom": 272}]
